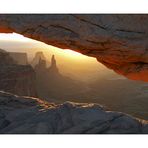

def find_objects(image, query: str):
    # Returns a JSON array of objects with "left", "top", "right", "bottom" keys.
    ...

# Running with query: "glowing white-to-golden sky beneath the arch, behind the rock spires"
[{"left": 0, "top": 33, "right": 119, "bottom": 81}]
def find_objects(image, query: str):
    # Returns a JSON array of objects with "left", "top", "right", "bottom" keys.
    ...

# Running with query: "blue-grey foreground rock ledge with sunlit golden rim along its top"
[{"left": 0, "top": 91, "right": 148, "bottom": 134}]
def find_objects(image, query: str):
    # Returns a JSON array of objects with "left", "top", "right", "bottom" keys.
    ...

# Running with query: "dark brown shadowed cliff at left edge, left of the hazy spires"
[{"left": 0, "top": 49, "right": 37, "bottom": 96}]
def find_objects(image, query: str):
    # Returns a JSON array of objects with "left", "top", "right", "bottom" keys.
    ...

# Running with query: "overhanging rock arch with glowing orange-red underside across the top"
[{"left": 0, "top": 14, "right": 148, "bottom": 82}]
